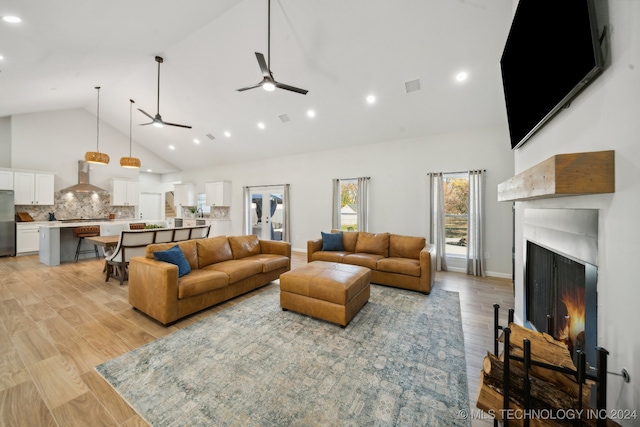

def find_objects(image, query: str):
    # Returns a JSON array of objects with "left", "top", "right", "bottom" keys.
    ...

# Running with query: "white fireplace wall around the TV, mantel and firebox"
[{"left": 515, "top": 0, "right": 640, "bottom": 416}]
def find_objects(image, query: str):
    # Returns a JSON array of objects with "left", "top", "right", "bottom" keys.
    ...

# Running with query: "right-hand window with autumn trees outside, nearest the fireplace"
[{"left": 443, "top": 173, "right": 469, "bottom": 257}]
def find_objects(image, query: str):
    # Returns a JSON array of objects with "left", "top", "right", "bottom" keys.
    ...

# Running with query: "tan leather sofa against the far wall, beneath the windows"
[{"left": 307, "top": 230, "right": 436, "bottom": 294}]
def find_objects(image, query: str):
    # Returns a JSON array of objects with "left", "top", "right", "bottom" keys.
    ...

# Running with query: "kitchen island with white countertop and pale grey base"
[{"left": 39, "top": 218, "right": 156, "bottom": 266}]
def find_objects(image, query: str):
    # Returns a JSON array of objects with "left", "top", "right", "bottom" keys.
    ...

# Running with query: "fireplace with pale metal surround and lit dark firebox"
[{"left": 523, "top": 209, "right": 598, "bottom": 366}]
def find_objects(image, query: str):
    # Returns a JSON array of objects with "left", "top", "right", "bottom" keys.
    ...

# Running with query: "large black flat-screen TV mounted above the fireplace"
[{"left": 500, "top": 0, "right": 604, "bottom": 149}]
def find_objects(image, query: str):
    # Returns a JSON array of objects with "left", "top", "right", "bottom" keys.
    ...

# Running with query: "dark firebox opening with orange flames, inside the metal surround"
[{"left": 525, "top": 241, "right": 597, "bottom": 366}]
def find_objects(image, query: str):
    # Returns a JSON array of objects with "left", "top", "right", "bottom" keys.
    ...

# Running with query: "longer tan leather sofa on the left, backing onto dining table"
[{"left": 129, "top": 235, "right": 291, "bottom": 325}]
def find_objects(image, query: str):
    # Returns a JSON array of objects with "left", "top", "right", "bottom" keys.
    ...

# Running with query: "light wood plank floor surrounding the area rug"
[{"left": 0, "top": 253, "right": 513, "bottom": 427}]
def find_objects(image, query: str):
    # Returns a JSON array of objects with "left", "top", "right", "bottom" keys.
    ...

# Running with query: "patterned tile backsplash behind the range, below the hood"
[{"left": 16, "top": 193, "right": 136, "bottom": 221}]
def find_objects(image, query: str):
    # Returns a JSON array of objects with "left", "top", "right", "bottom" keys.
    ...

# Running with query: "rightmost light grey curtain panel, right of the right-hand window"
[{"left": 467, "top": 170, "right": 485, "bottom": 276}]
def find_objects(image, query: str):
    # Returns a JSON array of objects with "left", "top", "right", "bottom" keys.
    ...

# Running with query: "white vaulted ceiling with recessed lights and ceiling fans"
[{"left": 0, "top": 0, "right": 512, "bottom": 173}]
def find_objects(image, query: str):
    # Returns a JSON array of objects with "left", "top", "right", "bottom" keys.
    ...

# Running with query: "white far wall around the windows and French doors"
[{"left": 182, "top": 128, "right": 513, "bottom": 277}]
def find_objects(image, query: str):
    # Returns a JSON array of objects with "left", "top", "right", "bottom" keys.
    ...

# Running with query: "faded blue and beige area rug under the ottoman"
[{"left": 95, "top": 285, "right": 469, "bottom": 427}]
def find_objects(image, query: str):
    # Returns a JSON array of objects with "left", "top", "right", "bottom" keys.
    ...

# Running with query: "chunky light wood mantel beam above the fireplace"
[{"left": 498, "top": 150, "right": 615, "bottom": 202}]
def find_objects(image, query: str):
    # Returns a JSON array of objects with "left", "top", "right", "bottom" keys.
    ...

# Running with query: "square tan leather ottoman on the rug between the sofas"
[{"left": 280, "top": 261, "right": 371, "bottom": 328}]
